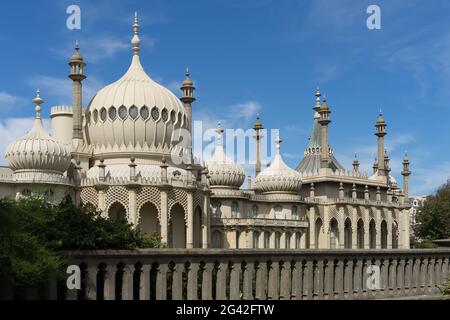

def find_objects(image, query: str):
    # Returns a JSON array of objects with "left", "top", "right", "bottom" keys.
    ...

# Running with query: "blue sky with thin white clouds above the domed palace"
[{"left": 0, "top": 0, "right": 450, "bottom": 194}]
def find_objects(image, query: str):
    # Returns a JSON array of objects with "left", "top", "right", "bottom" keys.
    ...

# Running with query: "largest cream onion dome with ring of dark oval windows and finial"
[{"left": 86, "top": 14, "right": 188, "bottom": 158}]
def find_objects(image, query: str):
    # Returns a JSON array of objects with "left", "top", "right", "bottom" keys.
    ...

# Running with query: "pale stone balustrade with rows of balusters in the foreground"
[{"left": 33, "top": 249, "right": 450, "bottom": 300}]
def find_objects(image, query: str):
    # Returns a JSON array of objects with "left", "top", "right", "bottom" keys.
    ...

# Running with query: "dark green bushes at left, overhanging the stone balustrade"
[{"left": 0, "top": 198, "right": 160, "bottom": 285}]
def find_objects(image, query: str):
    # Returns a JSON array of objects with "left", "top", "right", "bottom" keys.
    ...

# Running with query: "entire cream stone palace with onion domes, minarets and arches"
[{"left": 0, "top": 16, "right": 410, "bottom": 249}]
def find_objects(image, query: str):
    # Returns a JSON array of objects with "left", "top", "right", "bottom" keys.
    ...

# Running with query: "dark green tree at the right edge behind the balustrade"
[{"left": 414, "top": 181, "right": 450, "bottom": 240}]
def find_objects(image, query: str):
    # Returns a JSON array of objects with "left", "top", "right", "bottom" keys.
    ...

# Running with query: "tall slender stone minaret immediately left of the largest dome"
[{"left": 69, "top": 41, "right": 86, "bottom": 147}]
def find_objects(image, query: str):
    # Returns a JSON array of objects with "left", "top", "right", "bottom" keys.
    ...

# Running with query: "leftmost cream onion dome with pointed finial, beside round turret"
[{"left": 5, "top": 90, "right": 71, "bottom": 175}]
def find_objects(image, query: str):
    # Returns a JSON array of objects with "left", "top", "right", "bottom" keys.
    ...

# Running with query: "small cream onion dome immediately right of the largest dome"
[{"left": 206, "top": 123, "right": 245, "bottom": 189}]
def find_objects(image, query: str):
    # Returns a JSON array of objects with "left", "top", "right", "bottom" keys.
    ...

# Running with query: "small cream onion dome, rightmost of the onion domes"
[{"left": 255, "top": 134, "right": 302, "bottom": 192}]
